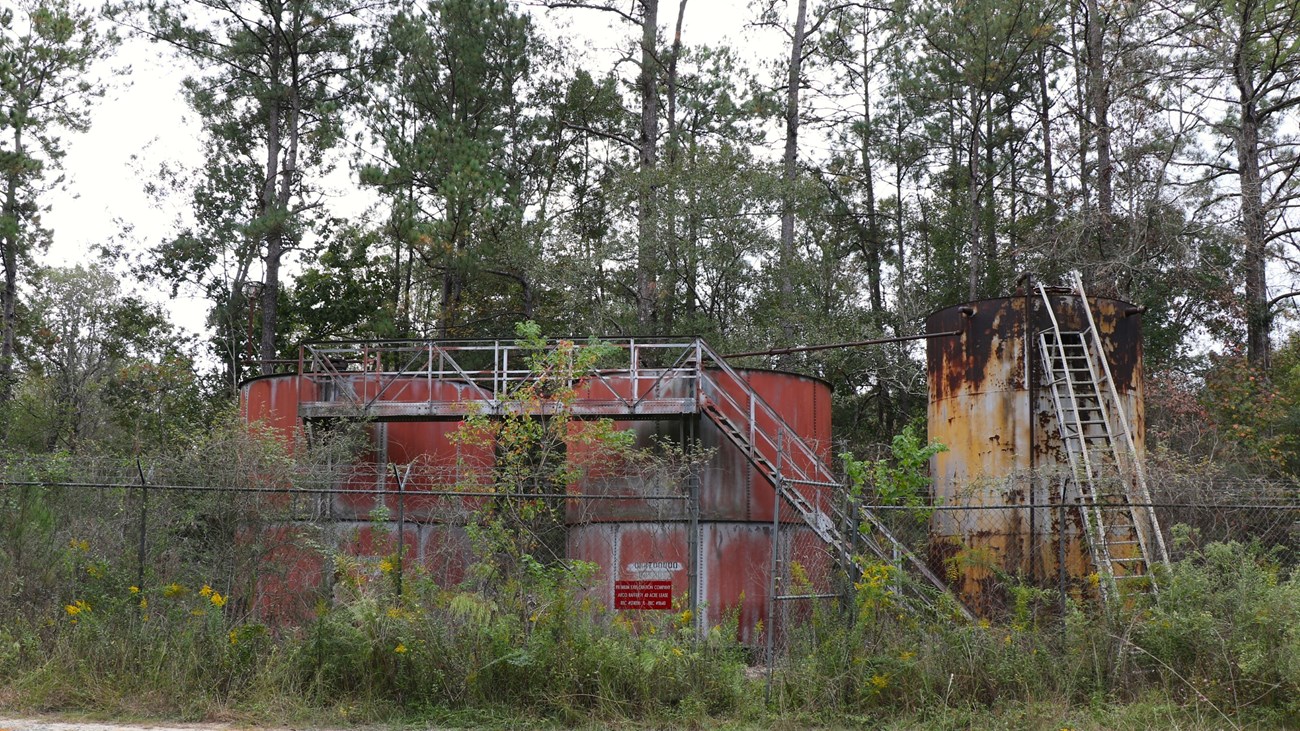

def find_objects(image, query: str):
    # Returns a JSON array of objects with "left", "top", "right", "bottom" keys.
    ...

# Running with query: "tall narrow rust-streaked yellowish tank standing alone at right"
[{"left": 926, "top": 287, "right": 1145, "bottom": 611}]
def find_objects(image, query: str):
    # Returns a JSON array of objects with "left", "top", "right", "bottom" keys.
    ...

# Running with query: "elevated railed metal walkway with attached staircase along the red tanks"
[{"left": 298, "top": 338, "right": 971, "bottom": 618}]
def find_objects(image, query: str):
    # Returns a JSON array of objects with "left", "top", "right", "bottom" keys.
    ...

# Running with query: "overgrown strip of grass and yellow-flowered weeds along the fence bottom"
[{"left": 0, "top": 525, "right": 1300, "bottom": 731}]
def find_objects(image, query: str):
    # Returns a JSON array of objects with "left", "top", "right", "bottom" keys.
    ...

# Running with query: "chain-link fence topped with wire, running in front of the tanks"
[{"left": 0, "top": 449, "right": 1300, "bottom": 645}]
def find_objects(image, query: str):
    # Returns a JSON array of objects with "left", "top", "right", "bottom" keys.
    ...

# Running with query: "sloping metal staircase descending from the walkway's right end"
[{"left": 697, "top": 342, "right": 974, "bottom": 611}]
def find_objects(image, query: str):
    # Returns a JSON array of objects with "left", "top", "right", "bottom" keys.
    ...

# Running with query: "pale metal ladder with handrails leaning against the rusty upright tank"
[{"left": 1039, "top": 272, "right": 1169, "bottom": 602}]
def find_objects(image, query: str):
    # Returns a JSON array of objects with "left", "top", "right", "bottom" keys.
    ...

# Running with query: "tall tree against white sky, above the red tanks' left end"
[{"left": 121, "top": 0, "right": 369, "bottom": 389}]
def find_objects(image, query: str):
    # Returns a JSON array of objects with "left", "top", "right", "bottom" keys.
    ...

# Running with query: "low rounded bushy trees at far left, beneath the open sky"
[{"left": 0, "top": 264, "right": 208, "bottom": 454}]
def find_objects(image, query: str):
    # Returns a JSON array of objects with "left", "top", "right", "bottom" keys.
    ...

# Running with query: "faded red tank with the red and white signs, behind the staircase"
[{"left": 568, "top": 368, "right": 833, "bottom": 644}]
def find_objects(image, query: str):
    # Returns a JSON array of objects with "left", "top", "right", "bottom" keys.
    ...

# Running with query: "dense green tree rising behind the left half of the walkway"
[{"left": 360, "top": 0, "right": 540, "bottom": 337}]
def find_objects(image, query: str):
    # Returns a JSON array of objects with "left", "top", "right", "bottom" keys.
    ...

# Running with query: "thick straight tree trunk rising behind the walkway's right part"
[{"left": 637, "top": 0, "right": 659, "bottom": 334}]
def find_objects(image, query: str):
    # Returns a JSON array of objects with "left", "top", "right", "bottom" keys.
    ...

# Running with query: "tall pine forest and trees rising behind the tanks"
[{"left": 0, "top": 0, "right": 1300, "bottom": 494}]
